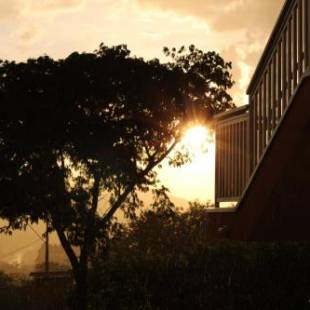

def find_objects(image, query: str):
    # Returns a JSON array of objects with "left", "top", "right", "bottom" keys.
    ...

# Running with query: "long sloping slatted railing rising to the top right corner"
[{"left": 248, "top": 0, "right": 310, "bottom": 170}]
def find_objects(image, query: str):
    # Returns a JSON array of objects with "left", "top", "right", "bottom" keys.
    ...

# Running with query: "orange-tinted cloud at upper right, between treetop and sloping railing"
[{"left": 136, "top": 0, "right": 284, "bottom": 105}]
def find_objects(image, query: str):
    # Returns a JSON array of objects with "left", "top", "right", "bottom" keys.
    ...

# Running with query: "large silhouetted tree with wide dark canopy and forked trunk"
[{"left": 0, "top": 44, "right": 232, "bottom": 309}]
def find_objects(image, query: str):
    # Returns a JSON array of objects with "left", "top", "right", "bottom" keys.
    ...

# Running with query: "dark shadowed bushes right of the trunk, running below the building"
[{"left": 91, "top": 207, "right": 310, "bottom": 310}]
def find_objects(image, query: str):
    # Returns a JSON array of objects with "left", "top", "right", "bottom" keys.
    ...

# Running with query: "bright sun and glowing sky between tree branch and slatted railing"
[{"left": 159, "top": 124, "right": 215, "bottom": 202}]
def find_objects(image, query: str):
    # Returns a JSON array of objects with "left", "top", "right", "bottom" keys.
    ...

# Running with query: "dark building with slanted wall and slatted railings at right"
[{"left": 208, "top": 0, "right": 310, "bottom": 241}]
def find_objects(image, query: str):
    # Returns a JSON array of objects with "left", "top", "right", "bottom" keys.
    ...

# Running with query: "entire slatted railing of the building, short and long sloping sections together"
[{"left": 215, "top": 0, "right": 310, "bottom": 204}]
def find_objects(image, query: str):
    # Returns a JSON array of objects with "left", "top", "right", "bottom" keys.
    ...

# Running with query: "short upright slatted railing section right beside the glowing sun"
[{"left": 215, "top": 106, "right": 250, "bottom": 205}]
